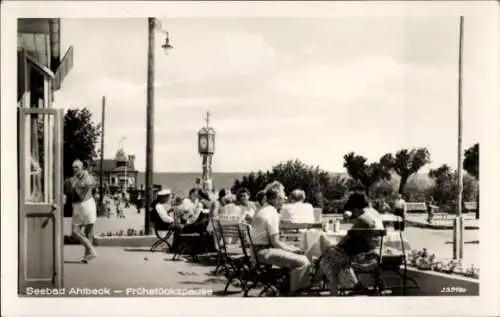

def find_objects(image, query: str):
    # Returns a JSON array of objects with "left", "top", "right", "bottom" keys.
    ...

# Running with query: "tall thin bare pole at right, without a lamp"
[{"left": 453, "top": 16, "right": 464, "bottom": 259}]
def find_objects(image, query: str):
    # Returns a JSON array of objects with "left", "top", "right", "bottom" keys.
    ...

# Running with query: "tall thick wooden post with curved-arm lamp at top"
[{"left": 144, "top": 17, "right": 173, "bottom": 234}]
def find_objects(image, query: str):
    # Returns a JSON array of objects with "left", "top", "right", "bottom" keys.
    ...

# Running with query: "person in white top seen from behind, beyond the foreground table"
[{"left": 280, "top": 189, "right": 315, "bottom": 223}]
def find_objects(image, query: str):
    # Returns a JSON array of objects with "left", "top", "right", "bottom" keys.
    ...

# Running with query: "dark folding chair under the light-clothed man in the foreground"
[{"left": 239, "top": 223, "right": 290, "bottom": 297}]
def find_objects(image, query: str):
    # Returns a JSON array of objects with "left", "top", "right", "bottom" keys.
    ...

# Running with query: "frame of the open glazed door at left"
[{"left": 17, "top": 107, "right": 64, "bottom": 294}]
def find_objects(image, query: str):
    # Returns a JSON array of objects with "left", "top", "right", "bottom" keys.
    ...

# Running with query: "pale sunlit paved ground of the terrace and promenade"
[{"left": 64, "top": 209, "right": 479, "bottom": 296}]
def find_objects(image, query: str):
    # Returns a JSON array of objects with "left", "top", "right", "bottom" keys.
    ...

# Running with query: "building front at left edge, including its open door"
[{"left": 17, "top": 18, "right": 73, "bottom": 294}]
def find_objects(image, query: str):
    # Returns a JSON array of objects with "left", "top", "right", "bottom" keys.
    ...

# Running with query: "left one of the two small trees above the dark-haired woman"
[{"left": 344, "top": 152, "right": 391, "bottom": 194}]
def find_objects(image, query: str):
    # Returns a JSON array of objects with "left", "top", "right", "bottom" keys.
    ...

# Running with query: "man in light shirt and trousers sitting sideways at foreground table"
[{"left": 252, "top": 187, "right": 310, "bottom": 292}]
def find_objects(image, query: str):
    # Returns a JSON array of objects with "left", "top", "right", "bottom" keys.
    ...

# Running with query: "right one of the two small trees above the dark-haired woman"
[{"left": 380, "top": 148, "right": 431, "bottom": 194}]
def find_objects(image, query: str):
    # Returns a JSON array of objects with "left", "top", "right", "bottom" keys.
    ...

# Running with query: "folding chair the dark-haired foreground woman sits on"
[{"left": 339, "top": 229, "right": 387, "bottom": 295}]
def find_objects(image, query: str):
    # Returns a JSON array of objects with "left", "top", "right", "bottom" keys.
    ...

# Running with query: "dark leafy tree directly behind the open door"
[{"left": 63, "top": 108, "right": 101, "bottom": 178}]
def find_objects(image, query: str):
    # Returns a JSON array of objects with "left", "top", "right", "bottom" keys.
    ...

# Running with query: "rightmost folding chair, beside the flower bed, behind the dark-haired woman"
[{"left": 381, "top": 217, "right": 420, "bottom": 295}]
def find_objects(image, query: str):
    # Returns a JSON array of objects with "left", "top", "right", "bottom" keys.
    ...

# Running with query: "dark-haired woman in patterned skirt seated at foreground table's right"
[{"left": 320, "top": 192, "right": 384, "bottom": 296}]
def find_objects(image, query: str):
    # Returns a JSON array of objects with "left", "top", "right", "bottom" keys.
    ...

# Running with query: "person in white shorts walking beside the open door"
[{"left": 65, "top": 160, "right": 97, "bottom": 263}]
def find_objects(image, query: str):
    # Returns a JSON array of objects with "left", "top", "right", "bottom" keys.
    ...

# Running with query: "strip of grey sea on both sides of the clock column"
[{"left": 137, "top": 172, "right": 248, "bottom": 196}]
